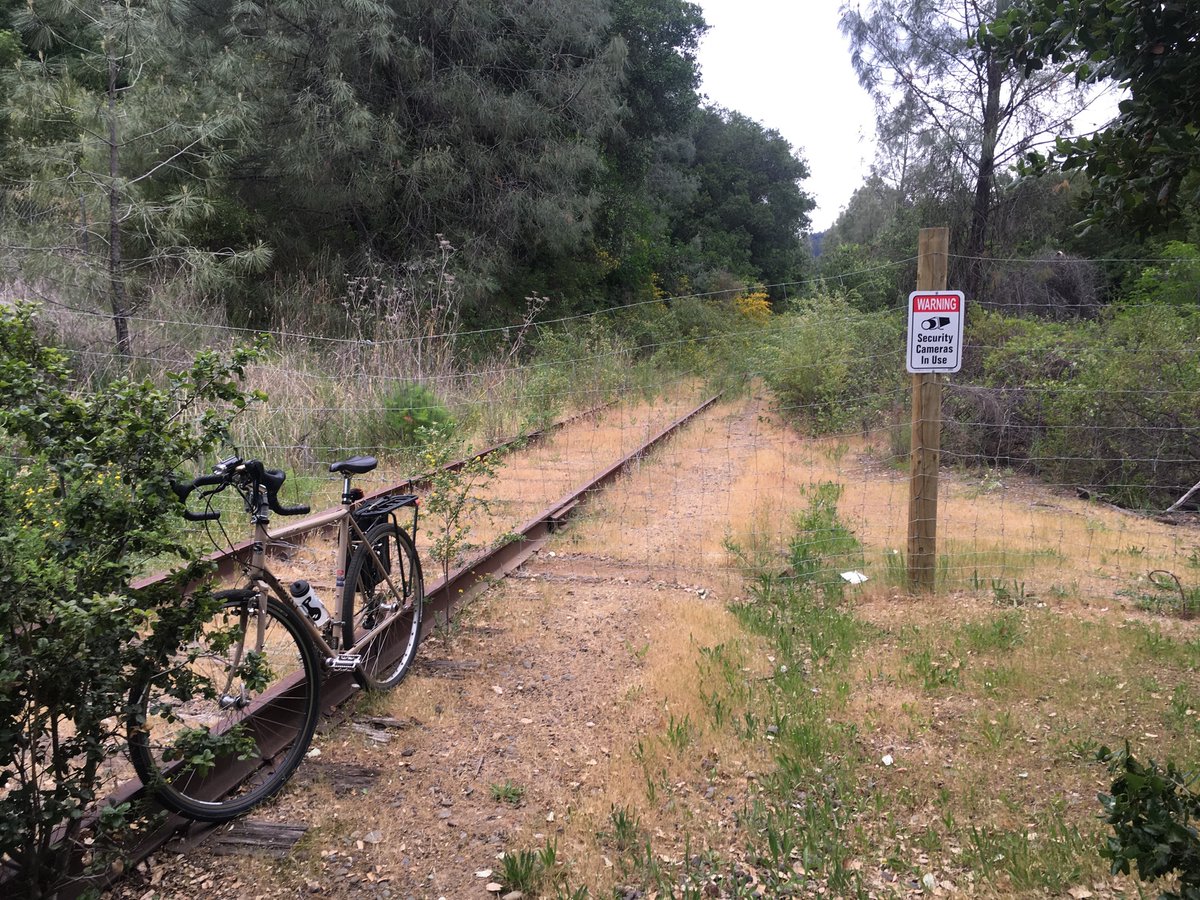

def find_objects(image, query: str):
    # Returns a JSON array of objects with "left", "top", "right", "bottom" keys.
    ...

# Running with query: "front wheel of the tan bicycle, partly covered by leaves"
[{"left": 127, "top": 589, "right": 320, "bottom": 822}]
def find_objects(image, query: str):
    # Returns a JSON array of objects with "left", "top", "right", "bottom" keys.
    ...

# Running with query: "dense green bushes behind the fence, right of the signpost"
[{"left": 943, "top": 304, "right": 1200, "bottom": 506}]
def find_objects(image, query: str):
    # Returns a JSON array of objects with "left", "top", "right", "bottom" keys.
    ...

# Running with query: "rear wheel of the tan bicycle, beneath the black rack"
[{"left": 342, "top": 522, "right": 425, "bottom": 690}]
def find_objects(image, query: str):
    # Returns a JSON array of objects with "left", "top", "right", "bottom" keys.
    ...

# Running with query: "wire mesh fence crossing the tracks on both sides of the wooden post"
[{"left": 4, "top": 256, "right": 1200, "bottom": 604}]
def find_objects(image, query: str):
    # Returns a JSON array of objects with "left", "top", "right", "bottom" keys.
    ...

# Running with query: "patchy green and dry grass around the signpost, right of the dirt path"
[{"left": 410, "top": 416, "right": 1200, "bottom": 896}]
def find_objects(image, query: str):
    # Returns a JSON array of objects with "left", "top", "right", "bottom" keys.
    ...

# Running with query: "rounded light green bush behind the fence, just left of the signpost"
[{"left": 762, "top": 294, "right": 904, "bottom": 432}]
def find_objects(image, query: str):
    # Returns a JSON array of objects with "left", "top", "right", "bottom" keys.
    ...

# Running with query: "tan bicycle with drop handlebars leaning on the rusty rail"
[{"left": 127, "top": 456, "right": 425, "bottom": 822}]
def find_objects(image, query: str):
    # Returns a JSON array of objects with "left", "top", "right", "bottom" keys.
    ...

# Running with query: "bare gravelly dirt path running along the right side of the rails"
[{"left": 119, "top": 400, "right": 781, "bottom": 898}]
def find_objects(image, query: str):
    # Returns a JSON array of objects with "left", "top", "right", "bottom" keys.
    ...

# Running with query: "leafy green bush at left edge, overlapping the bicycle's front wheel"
[{"left": 0, "top": 305, "right": 254, "bottom": 894}]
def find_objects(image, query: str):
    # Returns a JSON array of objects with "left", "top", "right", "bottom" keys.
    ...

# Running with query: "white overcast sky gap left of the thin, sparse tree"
[{"left": 696, "top": 0, "right": 875, "bottom": 232}]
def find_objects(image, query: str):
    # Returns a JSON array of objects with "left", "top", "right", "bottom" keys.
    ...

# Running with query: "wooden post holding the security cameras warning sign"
[{"left": 908, "top": 228, "right": 950, "bottom": 590}]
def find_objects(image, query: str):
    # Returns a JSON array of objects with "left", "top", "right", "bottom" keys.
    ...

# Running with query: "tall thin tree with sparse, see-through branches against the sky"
[{"left": 841, "top": 0, "right": 1086, "bottom": 287}]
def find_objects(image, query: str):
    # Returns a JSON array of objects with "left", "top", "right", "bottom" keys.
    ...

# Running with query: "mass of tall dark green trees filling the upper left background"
[{"left": 0, "top": 0, "right": 812, "bottom": 330}]
